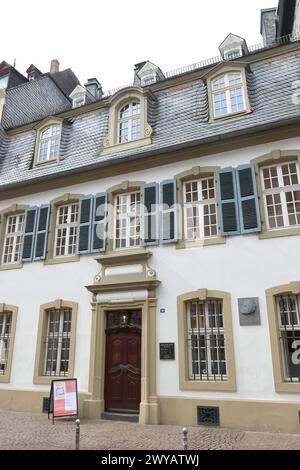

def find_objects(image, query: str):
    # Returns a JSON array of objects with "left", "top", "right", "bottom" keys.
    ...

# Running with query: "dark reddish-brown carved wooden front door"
[{"left": 104, "top": 329, "right": 141, "bottom": 413}]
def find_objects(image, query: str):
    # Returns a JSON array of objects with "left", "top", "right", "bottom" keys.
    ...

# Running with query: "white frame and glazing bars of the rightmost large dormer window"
[{"left": 211, "top": 71, "right": 247, "bottom": 119}]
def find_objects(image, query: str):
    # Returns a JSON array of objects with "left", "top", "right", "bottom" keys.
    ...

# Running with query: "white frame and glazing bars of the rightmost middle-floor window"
[{"left": 260, "top": 160, "right": 300, "bottom": 231}]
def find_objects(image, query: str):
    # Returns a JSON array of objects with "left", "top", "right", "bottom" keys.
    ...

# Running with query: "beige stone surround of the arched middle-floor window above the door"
[{"left": 106, "top": 181, "right": 145, "bottom": 254}]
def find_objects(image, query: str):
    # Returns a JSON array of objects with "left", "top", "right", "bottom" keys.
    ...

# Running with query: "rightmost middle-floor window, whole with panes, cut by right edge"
[{"left": 261, "top": 161, "right": 300, "bottom": 230}]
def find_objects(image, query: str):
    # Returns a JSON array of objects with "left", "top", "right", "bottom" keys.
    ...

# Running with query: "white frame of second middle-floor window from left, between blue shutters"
[{"left": 53, "top": 202, "right": 79, "bottom": 258}]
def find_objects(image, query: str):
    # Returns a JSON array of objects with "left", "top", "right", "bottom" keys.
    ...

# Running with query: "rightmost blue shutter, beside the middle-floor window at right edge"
[{"left": 236, "top": 165, "right": 261, "bottom": 233}]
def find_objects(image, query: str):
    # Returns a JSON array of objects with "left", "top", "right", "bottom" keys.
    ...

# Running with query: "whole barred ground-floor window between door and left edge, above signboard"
[{"left": 44, "top": 308, "right": 72, "bottom": 376}]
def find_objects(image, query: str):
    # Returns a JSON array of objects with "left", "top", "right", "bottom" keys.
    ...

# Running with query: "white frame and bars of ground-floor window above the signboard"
[{"left": 43, "top": 307, "right": 72, "bottom": 377}]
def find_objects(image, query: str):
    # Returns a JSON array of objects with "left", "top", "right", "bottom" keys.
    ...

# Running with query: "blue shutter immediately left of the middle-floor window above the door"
[{"left": 91, "top": 193, "right": 107, "bottom": 253}]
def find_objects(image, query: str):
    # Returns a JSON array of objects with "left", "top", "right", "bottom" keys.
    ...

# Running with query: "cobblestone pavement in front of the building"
[{"left": 0, "top": 410, "right": 300, "bottom": 450}]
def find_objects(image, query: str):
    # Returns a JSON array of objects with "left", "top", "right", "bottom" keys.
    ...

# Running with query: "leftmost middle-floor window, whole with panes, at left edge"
[{"left": 2, "top": 214, "right": 24, "bottom": 264}]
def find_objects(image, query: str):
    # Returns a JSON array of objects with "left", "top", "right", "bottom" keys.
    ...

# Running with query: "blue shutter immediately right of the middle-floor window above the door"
[{"left": 141, "top": 183, "right": 159, "bottom": 246}]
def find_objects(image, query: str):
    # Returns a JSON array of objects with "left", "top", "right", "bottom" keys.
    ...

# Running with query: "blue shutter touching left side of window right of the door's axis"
[{"left": 160, "top": 180, "right": 178, "bottom": 243}]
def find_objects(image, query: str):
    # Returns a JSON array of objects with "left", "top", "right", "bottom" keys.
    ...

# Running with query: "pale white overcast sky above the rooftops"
[{"left": 0, "top": 0, "right": 278, "bottom": 90}]
